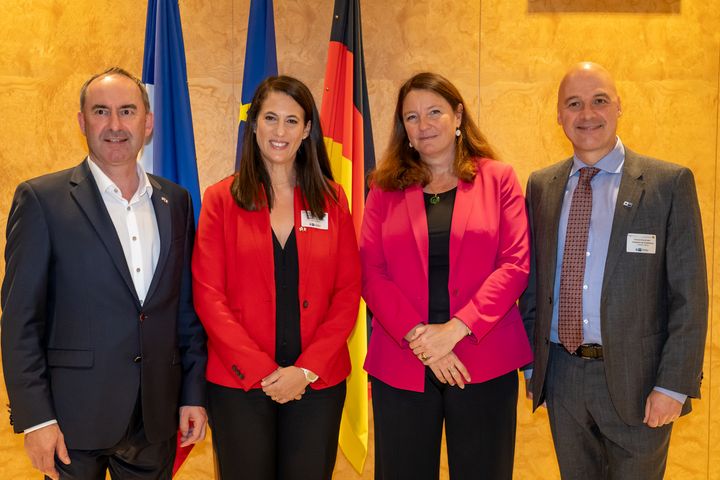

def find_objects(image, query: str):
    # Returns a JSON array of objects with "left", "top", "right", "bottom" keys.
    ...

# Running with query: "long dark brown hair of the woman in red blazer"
[{"left": 230, "top": 75, "right": 337, "bottom": 218}]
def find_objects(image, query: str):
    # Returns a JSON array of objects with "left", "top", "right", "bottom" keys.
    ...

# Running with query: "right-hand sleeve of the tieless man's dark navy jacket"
[{"left": 178, "top": 192, "right": 207, "bottom": 406}]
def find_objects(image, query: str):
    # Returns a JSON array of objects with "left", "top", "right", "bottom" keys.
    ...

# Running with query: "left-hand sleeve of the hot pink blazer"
[{"left": 360, "top": 187, "right": 427, "bottom": 348}]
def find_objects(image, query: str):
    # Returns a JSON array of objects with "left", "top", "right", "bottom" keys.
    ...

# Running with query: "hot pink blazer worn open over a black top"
[{"left": 360, "top": 159, "right": 532, "bottom": 392}]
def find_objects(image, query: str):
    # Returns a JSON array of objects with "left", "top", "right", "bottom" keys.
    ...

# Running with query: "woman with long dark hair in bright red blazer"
[{"left": 192, "top": 76, "right": 360, "bottom": 480}]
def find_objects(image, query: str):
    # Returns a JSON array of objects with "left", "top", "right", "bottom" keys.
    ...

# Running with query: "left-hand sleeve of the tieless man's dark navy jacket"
[{"left": 1, "top": 183, "right": 55, "bottom": 433}]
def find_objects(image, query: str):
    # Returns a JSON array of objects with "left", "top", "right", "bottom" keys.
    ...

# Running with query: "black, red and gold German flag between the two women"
[{"left": 320, "top": 0, "right": 375, "bottom": 473}]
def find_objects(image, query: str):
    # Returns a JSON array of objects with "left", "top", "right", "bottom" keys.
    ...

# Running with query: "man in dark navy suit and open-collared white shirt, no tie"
[{"left": 2, "top": 68, "right": 207, "bottom": 480}]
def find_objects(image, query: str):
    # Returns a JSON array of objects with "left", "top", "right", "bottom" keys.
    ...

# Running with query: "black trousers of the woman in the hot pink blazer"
[{"left": 371, "top": 368, "right": 518, "bottom": 480}]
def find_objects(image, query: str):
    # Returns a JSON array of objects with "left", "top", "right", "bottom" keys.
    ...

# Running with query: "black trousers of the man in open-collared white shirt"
[{"left": 51, "top": 398, "right": 177, "bottom": 480}]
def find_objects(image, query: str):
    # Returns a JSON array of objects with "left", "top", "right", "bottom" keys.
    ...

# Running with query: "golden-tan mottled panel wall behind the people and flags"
[{"left": 0, "top": 0, "right": 720, "bottom": 480}]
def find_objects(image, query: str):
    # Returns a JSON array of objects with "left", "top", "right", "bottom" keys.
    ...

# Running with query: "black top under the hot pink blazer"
[{"left": 423, "top": 187, "right": 457, "bottom": 323}]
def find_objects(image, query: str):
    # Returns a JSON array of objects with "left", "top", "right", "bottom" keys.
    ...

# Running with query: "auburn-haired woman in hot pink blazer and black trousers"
[{"left": 360, "top": 73, "right": 532, "bottom": 480}]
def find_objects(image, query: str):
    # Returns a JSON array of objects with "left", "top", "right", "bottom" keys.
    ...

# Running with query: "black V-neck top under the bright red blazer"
[{"left": 272, "top": 228, "right": 302, "bottom": 367}]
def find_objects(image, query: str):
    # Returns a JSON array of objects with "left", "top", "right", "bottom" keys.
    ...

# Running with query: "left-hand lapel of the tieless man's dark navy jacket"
[{"left": 70, "top": 160, "right": 140, "bottom": 303}]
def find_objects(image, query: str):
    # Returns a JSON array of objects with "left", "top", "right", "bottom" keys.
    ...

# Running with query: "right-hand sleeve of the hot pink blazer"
[{"left": 455, "top": 167, "right": 530, "bottom": 341}]
